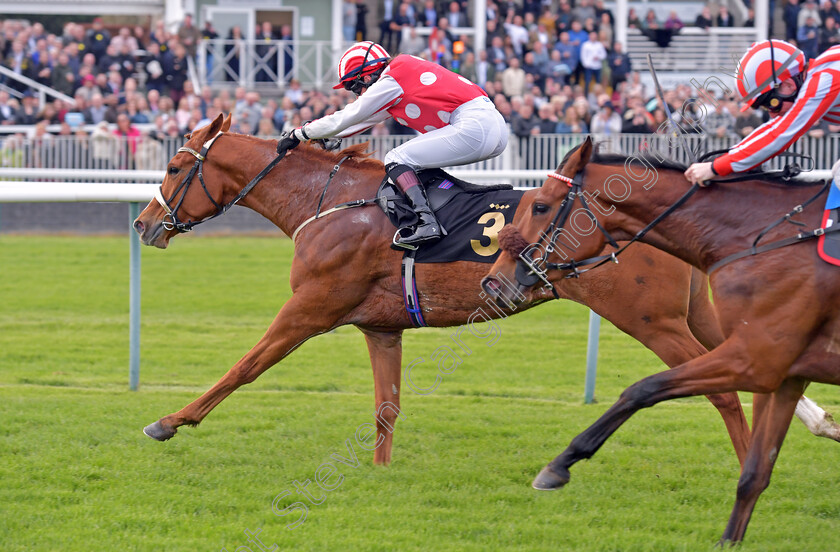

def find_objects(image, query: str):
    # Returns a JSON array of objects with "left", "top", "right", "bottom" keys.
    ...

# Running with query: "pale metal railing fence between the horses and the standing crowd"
[{"left": 0, "top": 134, "right": 840, "bottom": 186}]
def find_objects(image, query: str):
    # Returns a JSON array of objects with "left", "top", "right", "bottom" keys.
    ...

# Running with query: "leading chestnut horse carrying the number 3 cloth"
[{"left": 134, "top": 115, "right": 796, "bottom": 470}]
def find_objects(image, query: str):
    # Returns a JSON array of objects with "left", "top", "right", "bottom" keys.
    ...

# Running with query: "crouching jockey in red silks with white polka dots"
[{"left": 286, "top": 41, "right": 508, "bottom": 245}]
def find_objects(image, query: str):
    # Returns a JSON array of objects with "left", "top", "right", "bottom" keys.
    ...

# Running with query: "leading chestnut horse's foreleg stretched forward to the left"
[{"left": 143, "top": 293, "right": 347, "bottom": 441}]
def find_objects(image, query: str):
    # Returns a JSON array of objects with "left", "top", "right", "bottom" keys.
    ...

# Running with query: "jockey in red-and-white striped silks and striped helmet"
[{"left": 685, "top": 40, "right": 840, "bottom": 192}]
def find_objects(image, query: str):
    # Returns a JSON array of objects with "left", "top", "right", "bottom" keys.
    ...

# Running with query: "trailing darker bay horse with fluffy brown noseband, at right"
[{"left": 483, "top": 138, "right": 840, "bottom": 544}]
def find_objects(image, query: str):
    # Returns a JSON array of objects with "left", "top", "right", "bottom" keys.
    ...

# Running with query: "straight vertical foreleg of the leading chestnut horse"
[{"left": 360, "top": 328, "right": 402, "bottom": 465}]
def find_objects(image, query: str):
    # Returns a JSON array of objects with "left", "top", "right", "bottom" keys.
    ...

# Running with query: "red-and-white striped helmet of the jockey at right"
[{"left": 735, "top": 40, "right": 807, "bottom": 111}]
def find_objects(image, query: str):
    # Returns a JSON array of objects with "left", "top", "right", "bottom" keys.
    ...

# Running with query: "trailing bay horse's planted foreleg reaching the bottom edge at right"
[{"left": 720, "top": 378, "right": 805, "bottom": 545}]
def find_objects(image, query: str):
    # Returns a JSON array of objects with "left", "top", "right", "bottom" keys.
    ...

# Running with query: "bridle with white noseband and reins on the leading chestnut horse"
[{"left": 155, "top": 130, "right": 287, "bottom": 233}]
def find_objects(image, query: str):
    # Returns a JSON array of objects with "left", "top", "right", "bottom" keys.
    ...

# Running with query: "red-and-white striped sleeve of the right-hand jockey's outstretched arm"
[{"left": 712, "top": 70, "right": 840, "bottom": 176}]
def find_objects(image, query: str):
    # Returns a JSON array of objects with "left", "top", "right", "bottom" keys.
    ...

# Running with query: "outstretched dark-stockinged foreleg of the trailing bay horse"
[{"left": 534, "top": 339, "right": 786, "bottom": 490}]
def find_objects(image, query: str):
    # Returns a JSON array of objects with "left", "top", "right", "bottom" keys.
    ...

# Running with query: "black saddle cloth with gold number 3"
[{"left": 377, "top": 169, "right": 524, "bottom": 263}]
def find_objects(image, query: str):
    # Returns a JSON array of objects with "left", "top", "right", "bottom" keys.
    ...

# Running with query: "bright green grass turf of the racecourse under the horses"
[{"left": 0, "top": 236, "right": 840, "bottom": 552}]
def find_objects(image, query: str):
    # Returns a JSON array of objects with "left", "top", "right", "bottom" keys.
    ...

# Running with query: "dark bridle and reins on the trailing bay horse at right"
[{"left": 515, "top": 167, "right": 700, "bottom": 288}]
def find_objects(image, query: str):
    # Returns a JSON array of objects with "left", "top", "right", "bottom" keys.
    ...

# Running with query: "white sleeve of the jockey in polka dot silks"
[{"left": 304, "top": 75, "right": 403, "bottom": 139}]
